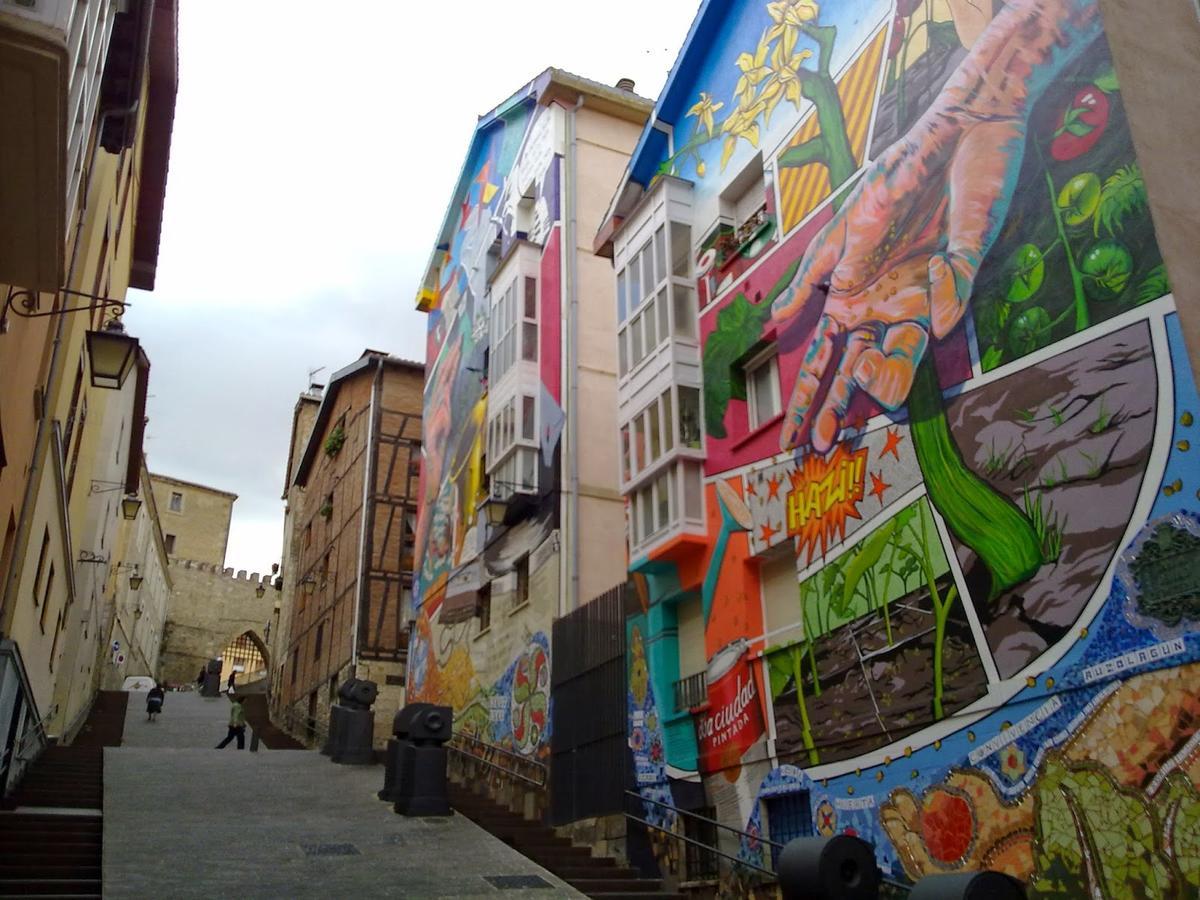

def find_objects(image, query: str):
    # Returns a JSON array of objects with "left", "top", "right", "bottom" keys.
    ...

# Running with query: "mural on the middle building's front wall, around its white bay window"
[{"left": 407, "top": 82, "right": 563, "bottom": 755}]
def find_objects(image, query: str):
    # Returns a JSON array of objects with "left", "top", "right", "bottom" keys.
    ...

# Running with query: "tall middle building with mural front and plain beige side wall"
[{"left": 407, "top": 68, "right": 650, "bottom": 777}]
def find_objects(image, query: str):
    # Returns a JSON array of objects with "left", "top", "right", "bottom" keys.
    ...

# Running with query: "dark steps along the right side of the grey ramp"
[{"left": 450, "top": 784, "right": 683, "bottom": 900}]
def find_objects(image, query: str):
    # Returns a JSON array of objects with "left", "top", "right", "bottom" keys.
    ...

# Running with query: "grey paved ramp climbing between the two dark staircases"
[{"left": 103, "top": 692, "right": 582, "bottom": 900}]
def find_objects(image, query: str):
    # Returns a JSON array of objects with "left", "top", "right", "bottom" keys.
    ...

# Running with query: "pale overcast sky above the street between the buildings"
[{"left": 126, "top": 0, "right": 698, "bottom": 571}]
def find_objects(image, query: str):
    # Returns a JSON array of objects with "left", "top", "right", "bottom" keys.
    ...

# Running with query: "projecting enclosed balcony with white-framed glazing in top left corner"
[{"left": 0, "top": 0, "right": 120, "bottom": 290}]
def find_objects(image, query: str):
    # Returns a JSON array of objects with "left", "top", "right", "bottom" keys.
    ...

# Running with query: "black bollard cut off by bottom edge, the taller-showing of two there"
[{"left": 776, "top": 834, "right": 880, "bottom": 900}]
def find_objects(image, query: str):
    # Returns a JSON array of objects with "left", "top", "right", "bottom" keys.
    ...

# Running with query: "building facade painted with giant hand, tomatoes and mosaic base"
[{"left": 596, "top": 0, "right": 1200, "bottom": 896}]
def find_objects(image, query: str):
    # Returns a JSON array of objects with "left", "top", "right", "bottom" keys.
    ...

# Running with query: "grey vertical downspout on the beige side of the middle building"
[{"left": 559, "top": 95, "right": 586, "bottom": 614}]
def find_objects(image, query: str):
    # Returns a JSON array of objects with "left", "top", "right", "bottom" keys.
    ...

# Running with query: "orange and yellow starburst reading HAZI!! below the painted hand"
[{"left": 786, "top": 444, "right": 866, "bottom": 563}]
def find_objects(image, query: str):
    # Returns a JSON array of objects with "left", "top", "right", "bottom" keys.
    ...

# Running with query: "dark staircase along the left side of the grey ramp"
[{"left": 0, "top": 691, "right": 128, "bottom": 898}]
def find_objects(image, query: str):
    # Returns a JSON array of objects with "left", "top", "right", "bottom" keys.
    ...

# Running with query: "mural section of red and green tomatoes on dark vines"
[{"left": 976, "top": 59, "right": 1169, "bottom": 371}]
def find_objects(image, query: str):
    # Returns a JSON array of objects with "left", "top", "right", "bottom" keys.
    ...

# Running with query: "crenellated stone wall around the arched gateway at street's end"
[{"left": 160, "top": 557, "right": 276, "bottom": 683}]
